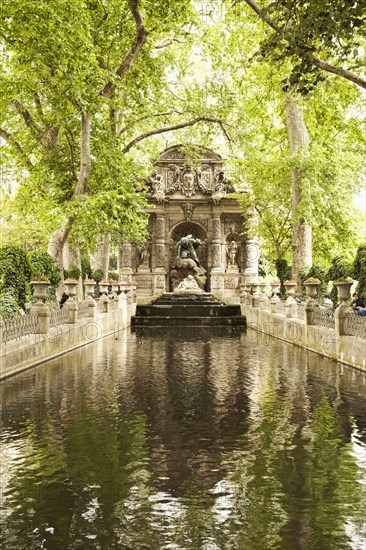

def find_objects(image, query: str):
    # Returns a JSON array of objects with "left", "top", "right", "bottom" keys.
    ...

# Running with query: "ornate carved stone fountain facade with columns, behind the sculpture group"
[{"left": 120, "top": 145, "right": 258, "bottom": 303}]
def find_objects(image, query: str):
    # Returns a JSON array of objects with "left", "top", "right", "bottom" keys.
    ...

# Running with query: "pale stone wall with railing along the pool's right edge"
[{"left": 241, "top": 296, "right": 366, "bottom": 372}]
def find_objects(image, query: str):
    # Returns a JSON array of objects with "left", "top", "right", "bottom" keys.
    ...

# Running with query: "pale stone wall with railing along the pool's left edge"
[{"left": 0, "top": 284, "right": 136, "bottom": 380}]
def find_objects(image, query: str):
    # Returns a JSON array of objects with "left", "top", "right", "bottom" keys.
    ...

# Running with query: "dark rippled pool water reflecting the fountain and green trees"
[{"left": 0, "top": 329, "right": 366, "bottom": 550}]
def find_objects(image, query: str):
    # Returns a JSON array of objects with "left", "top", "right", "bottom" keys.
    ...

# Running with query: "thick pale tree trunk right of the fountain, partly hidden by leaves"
[{"left": 286, "top": 100, "right": 312, "bottom": 284}]
